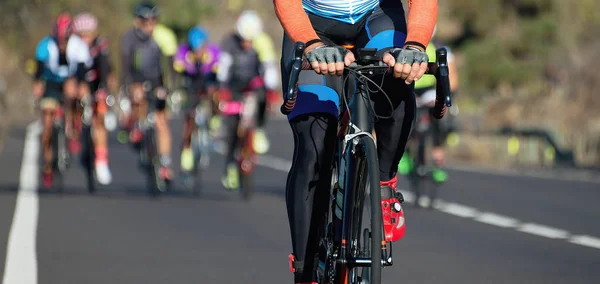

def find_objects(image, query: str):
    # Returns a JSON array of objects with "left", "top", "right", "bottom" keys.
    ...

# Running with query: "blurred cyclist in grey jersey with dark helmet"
[{"left": 121, "top": 2, "right": 172, "bottom": 180}]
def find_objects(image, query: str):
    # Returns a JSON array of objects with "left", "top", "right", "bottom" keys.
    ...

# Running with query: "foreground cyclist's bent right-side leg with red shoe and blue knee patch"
[{"left": 357, "top": 1, "right": 416, "bottom": 241}]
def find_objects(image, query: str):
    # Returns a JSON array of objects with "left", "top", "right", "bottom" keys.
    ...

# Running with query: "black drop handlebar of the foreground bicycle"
[{"left": 281, "top": 42, "right": 452, "bottom": 119}]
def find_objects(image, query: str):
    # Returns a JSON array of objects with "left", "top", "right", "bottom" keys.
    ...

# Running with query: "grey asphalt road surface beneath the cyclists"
[{"left": 0, "top": 116, "right": 600, "bottom": 284}]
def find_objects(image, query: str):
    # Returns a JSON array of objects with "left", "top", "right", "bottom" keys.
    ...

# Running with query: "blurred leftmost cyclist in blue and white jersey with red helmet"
[{"left": 33, "top": 13, "right": 91, "bottom": 188}]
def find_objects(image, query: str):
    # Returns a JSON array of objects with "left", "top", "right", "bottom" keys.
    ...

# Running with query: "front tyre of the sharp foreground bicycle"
[{"left": 339, "top": 136, "right": 383, "bottom": 284}]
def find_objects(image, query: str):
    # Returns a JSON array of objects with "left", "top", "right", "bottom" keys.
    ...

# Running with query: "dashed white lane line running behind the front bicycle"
[{"left": 250, "top": 155, "right": 600, "bottom": 249}]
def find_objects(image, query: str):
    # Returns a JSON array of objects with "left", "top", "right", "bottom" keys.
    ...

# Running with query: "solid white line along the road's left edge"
[{"left": 2, "top": 123, "right": 41, "bottom": 284}]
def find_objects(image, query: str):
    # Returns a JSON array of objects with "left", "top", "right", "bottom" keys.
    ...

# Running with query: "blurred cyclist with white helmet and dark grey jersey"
[{"left": 217, "top": 11, "right": 265, "bottom": 189}]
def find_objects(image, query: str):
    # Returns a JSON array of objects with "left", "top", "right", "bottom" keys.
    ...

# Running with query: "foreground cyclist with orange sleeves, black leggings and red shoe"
[{"left": 273, "top": 0, "right": 438, "bottom": 284}]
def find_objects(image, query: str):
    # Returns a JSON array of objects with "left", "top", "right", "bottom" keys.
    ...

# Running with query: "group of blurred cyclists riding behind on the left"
[{"left": 33, "top": 5, "right": 279, "bottom": 192}]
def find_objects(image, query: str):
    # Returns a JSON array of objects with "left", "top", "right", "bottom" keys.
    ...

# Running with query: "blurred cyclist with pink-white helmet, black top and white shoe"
[{"left": 73, "top": 13, "right": 116, "bottom": 185}]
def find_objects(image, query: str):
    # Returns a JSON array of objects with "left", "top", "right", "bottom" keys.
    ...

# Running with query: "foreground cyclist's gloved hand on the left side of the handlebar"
[{"left": 305, "top": 43, "right": 356, "bottom": 76}]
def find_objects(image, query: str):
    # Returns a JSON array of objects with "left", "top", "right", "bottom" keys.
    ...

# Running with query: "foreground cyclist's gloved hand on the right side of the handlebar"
[{"left": 383, "top": 46, "right": 429, "bottom": 85}]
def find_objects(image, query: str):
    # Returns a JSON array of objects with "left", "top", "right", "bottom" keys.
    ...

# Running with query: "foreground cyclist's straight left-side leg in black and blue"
[{"left": 281, "top": 30, "right": 341, "bottom": 283}]
